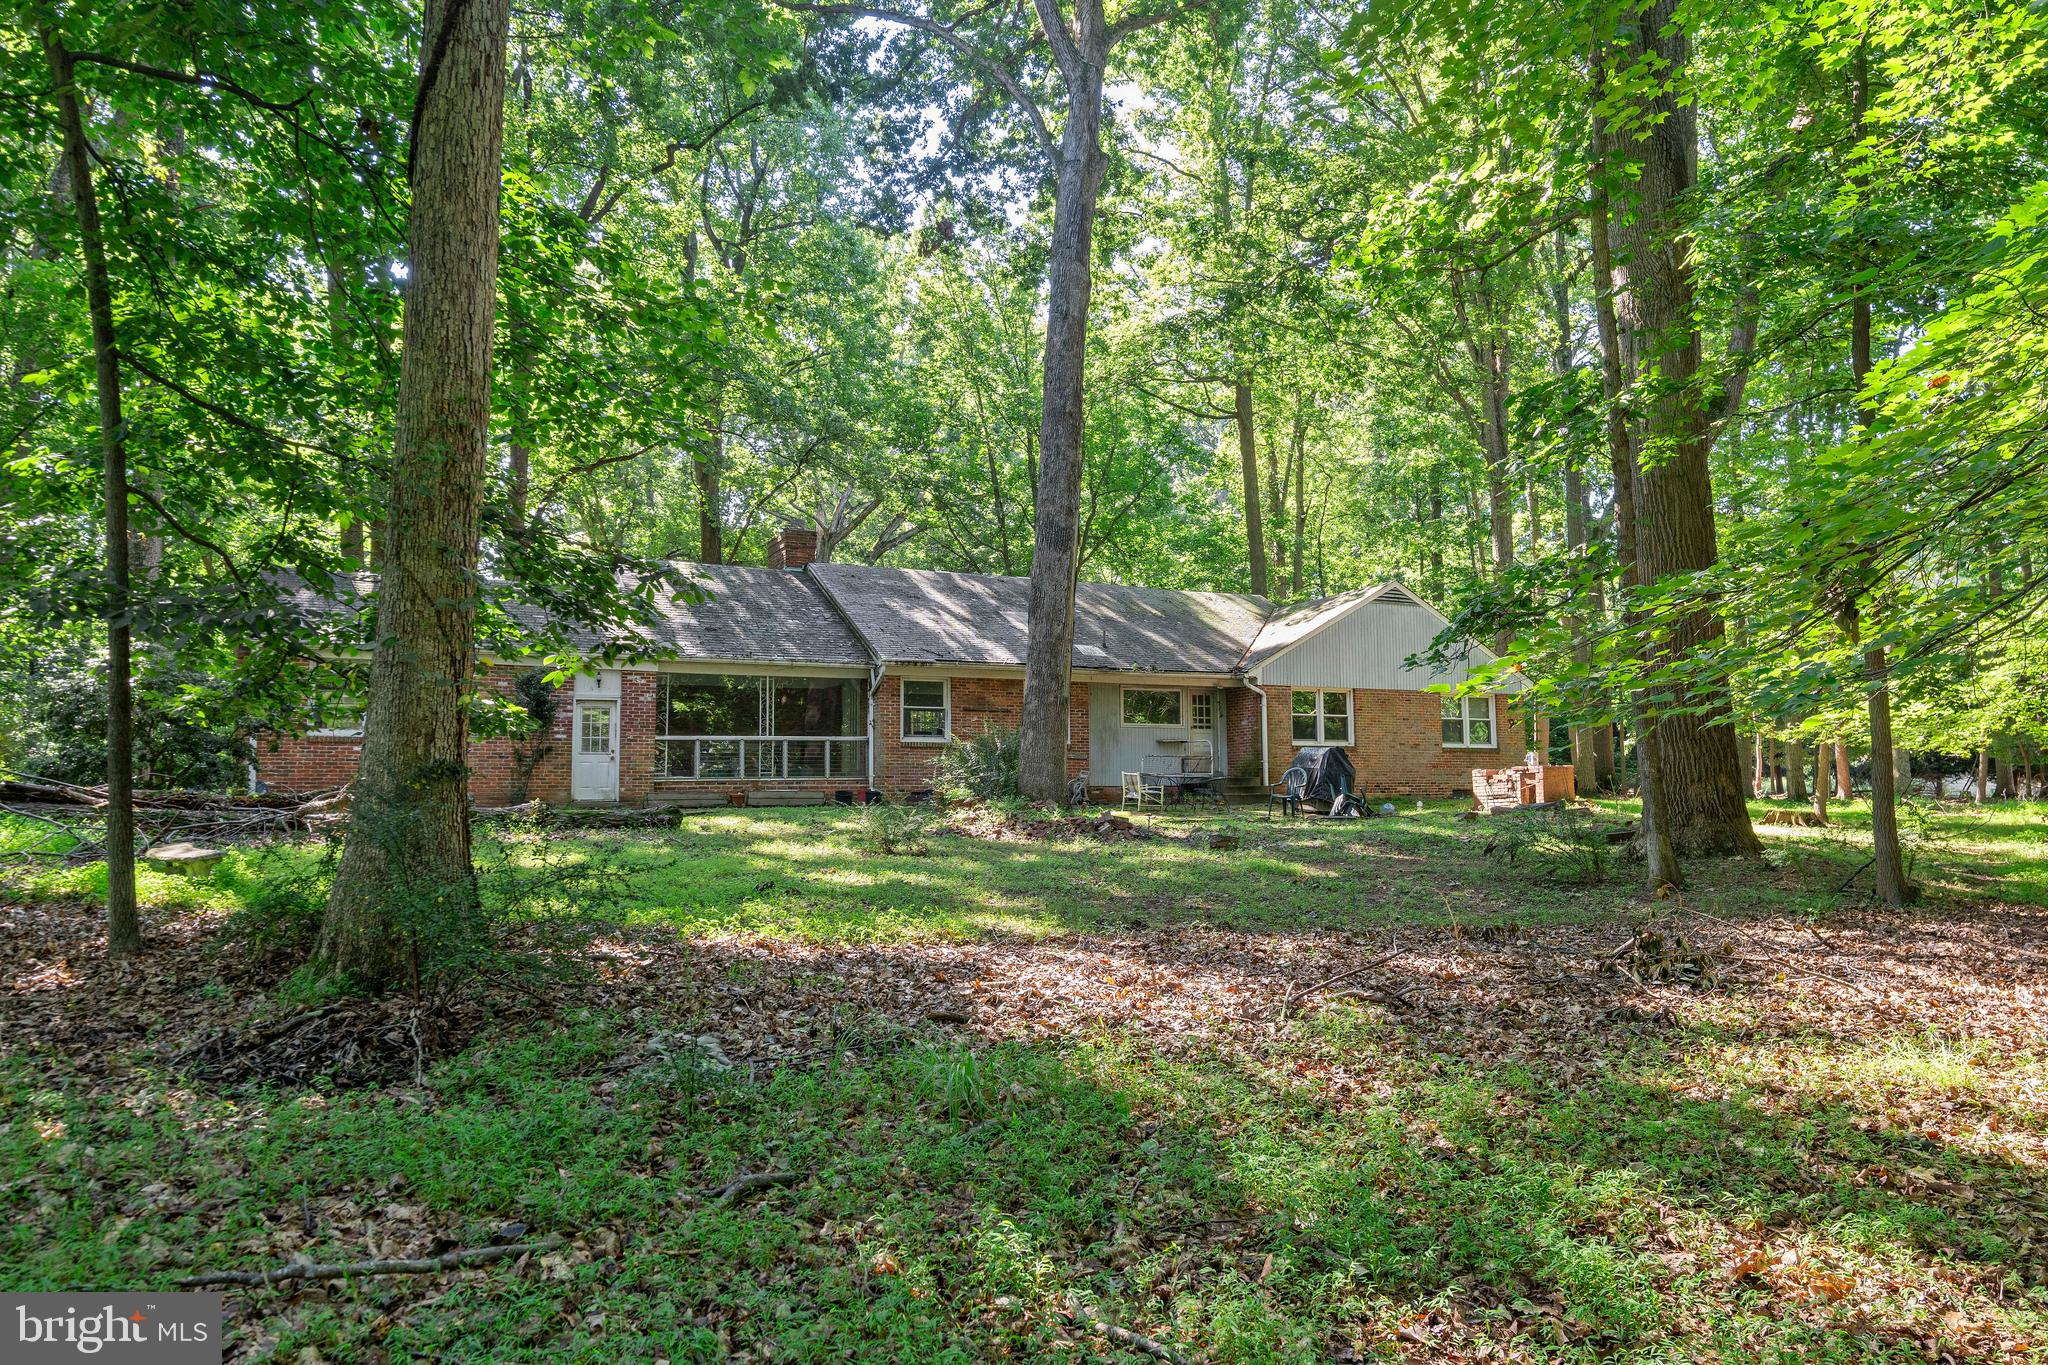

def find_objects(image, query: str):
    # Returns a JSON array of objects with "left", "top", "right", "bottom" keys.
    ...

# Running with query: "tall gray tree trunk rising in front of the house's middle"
[{"left": 1018, "top": 0, "right": 1114, "bottom": 802}]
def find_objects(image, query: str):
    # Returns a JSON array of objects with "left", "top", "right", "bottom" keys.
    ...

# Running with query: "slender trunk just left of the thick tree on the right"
[{"left": 1589, "top": 106, "right": 1683, "bottom": 888}]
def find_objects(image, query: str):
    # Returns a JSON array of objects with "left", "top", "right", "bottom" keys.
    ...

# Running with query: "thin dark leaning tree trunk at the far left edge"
[{"left": 43, "top": 29, "right": 141, "bottom": 958}]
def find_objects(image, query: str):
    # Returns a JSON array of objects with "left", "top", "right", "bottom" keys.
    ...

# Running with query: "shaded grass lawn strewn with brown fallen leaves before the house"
[{"left": 0, "top": 804, "right": 2048, "bottom": 1363}]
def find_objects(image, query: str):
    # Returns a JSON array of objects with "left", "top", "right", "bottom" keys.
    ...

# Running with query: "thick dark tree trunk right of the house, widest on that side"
[{"left": 1612, "top": 0, "right": 1763, "bottom": 857}]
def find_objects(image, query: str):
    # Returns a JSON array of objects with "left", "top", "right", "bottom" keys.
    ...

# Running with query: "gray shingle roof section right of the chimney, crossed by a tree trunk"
[{"left": 811, "top": 565, "right": 1272, "bottom": 673}]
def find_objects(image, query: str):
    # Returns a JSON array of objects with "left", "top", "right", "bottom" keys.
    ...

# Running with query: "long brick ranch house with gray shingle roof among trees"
[{"left": 256, "top": 528, "right": 1544, "bottom": 806}]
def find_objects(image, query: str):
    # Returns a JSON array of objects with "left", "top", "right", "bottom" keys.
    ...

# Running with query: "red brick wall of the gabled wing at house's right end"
[{"left": 1261, "top": 686, "right": 1526, "bottom": 800}]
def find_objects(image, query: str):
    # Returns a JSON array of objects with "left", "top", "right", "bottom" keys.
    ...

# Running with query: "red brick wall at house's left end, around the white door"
[{"left": 256, "top": 665, "right": 577, "bottom": 806}]
